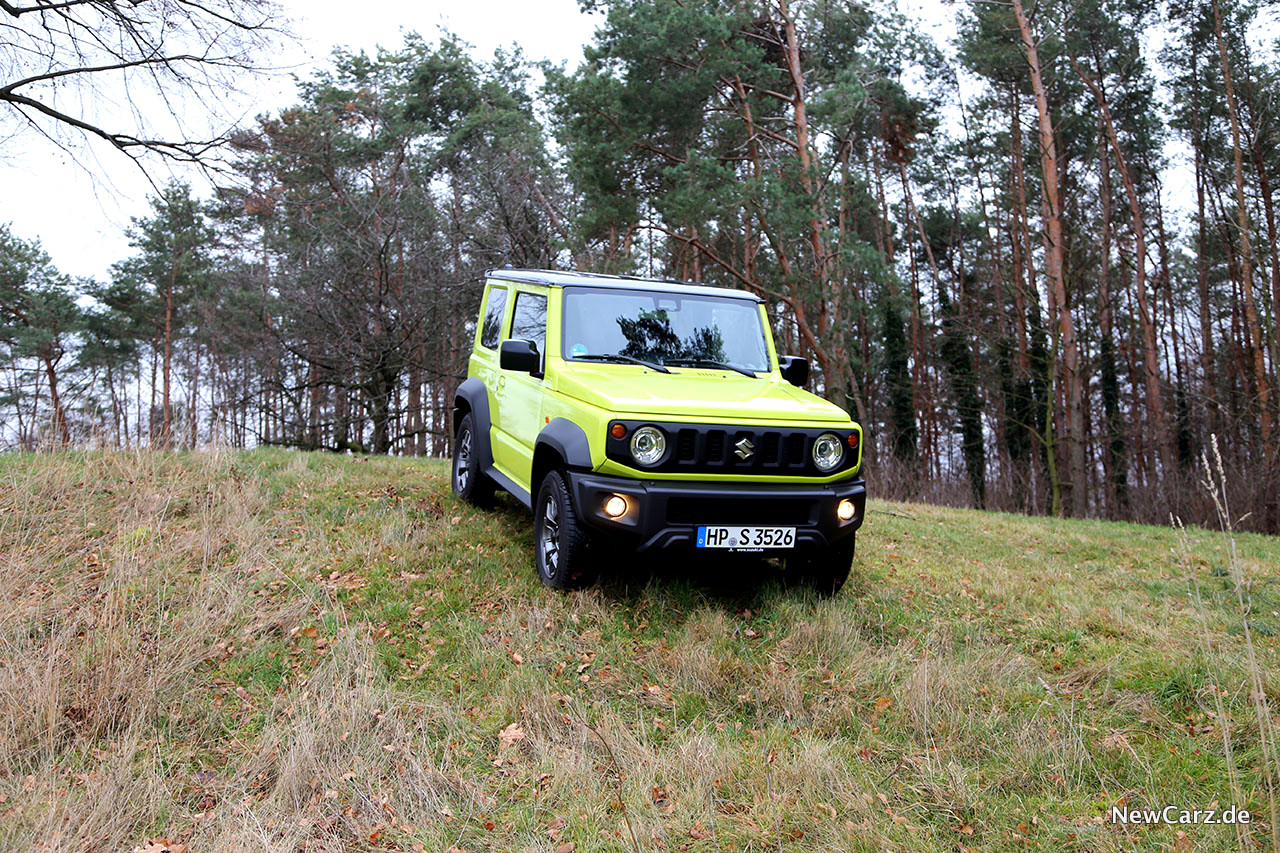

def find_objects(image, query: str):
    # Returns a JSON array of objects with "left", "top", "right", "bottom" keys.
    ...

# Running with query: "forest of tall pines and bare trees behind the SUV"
[{"left": 0, "top": 0, "right": 1280, "bottom": 533}]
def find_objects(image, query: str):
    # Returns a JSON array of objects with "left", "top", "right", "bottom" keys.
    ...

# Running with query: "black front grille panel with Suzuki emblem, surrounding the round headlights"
[{"left": 604, "top": 420, "right": 859, "bottom": 476}]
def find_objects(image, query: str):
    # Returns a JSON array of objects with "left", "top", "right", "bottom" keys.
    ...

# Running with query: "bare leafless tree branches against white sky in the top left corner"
[{"left": 0, "top": 0, "right": 283, "bottom": 163}]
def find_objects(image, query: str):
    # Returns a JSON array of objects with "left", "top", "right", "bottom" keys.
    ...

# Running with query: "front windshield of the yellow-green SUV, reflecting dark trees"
[{"left": 562, "top": 287, "right": 769, "bottom": 371}]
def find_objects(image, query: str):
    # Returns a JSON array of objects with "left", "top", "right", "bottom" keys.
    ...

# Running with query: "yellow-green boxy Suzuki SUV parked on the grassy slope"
[{"left": 453, "top": 269, "right": 867, "bottom": 592}]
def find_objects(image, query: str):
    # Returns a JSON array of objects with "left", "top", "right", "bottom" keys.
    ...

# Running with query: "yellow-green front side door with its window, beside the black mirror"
[{"left": 494, "top": 287, "right": 548, "bottom": 492}]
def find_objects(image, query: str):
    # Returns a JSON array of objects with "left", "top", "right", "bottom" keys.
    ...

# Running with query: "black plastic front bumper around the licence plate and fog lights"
[{"left": 568, "top": 471, "right": 867, "bottom": 553}]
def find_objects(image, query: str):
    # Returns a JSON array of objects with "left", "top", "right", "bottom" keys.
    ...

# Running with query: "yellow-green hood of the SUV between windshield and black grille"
[{"left": 556, "top": 364, "right": 849, "bottom": 423}]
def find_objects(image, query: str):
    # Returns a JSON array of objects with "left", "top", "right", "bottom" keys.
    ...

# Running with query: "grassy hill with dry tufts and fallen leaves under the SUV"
[{"left": 0, "top": 452, "right": 1280, "bottom": 853}]
